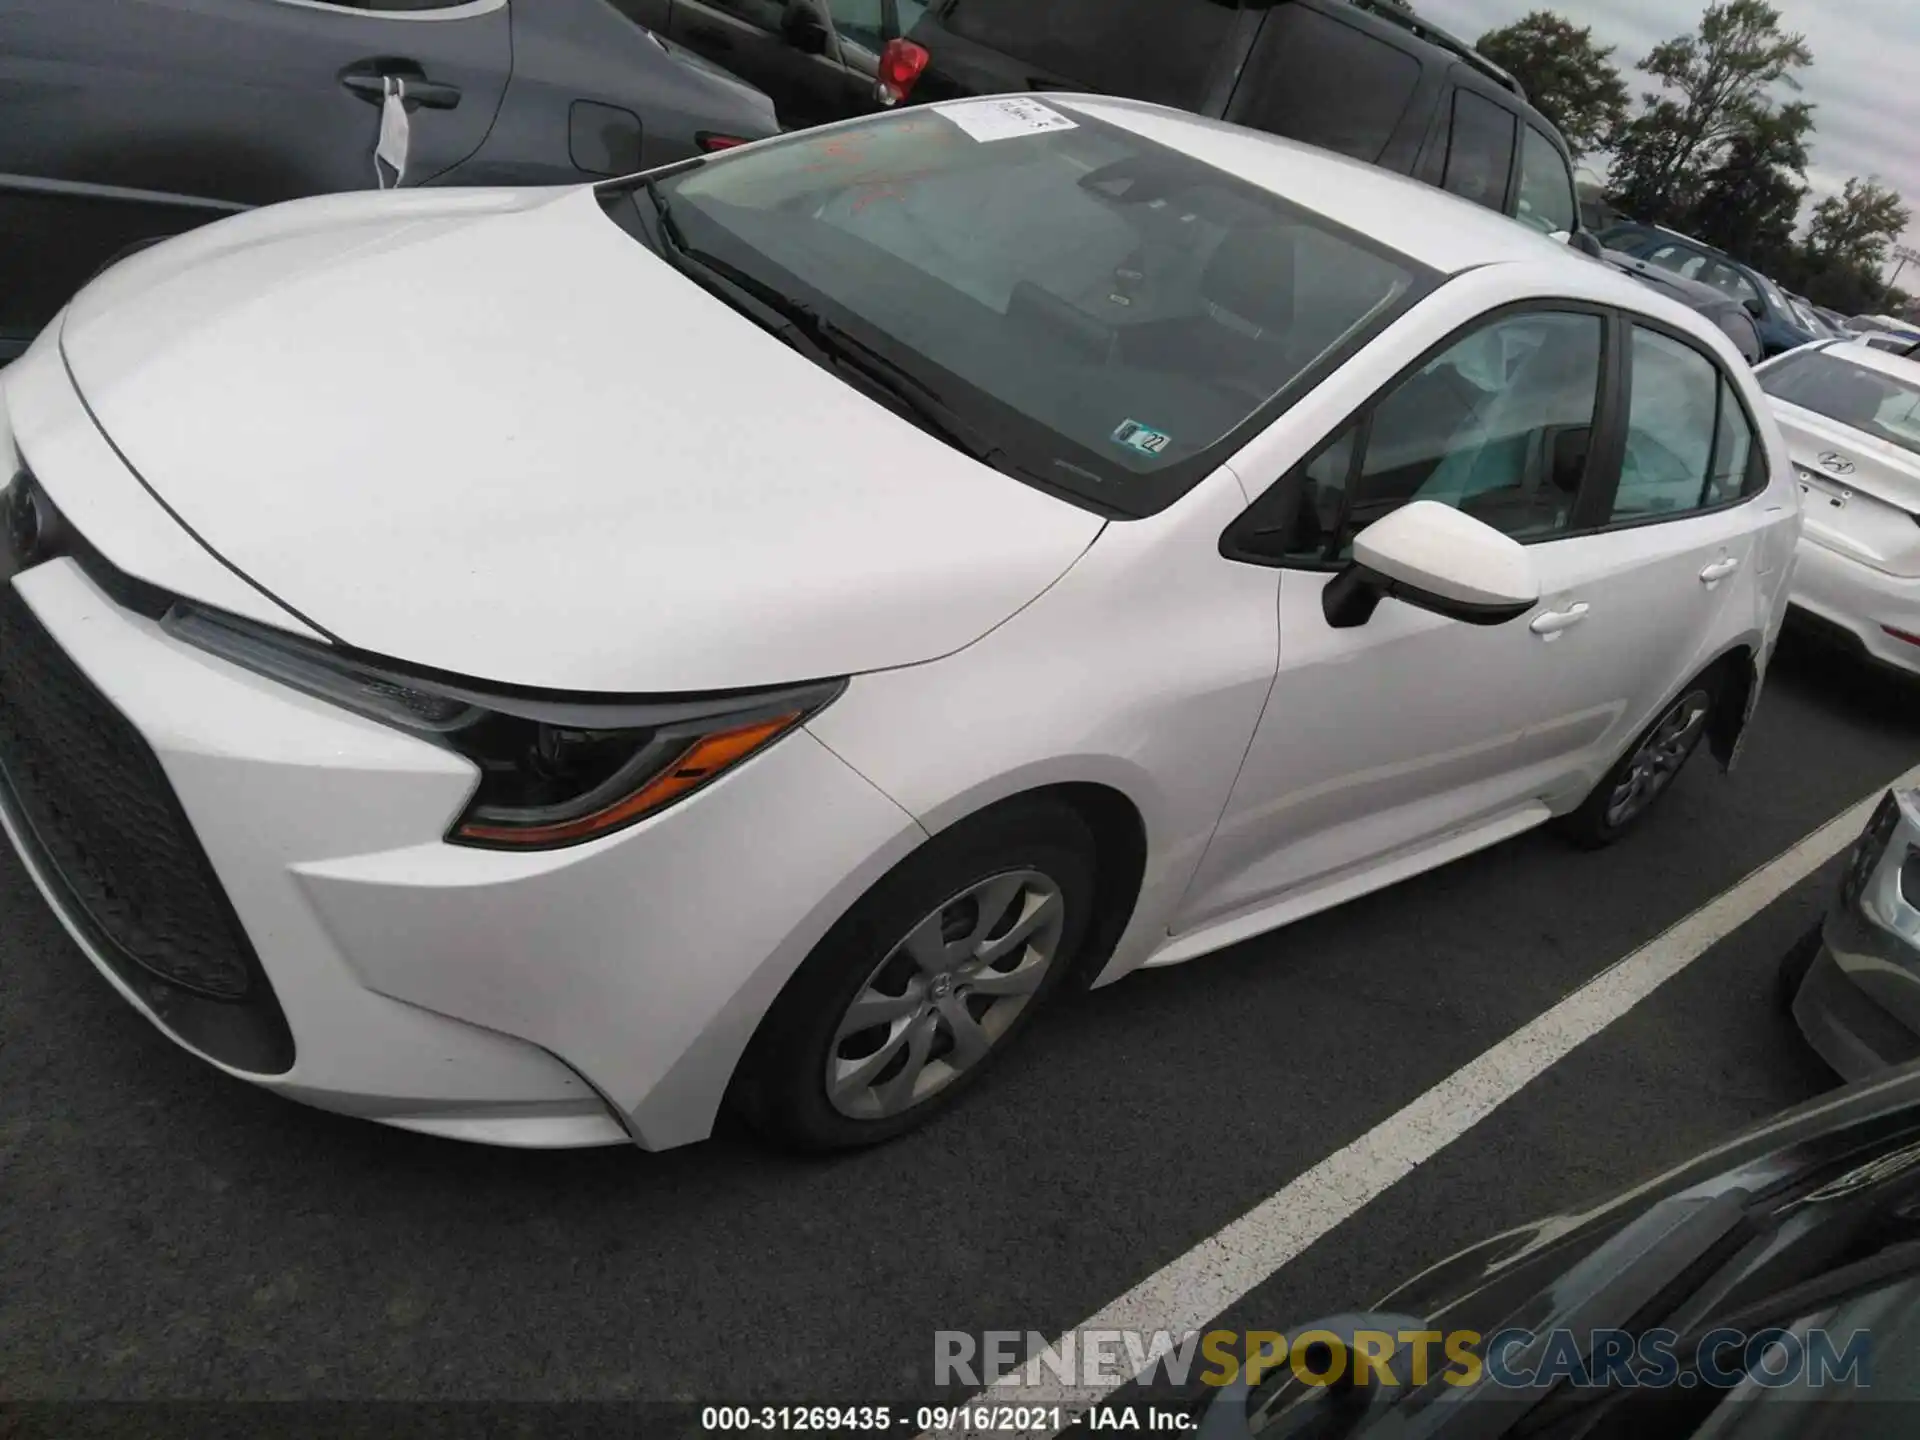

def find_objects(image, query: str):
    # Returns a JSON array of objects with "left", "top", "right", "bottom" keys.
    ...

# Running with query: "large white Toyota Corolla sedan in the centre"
[{"left": 0, "top": 96, "right": 1799, "bottom": 1148}]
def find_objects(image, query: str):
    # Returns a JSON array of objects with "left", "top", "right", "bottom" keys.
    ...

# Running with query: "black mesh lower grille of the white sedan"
[{"left": 0, "top": 582, "right": 292, "bottom": 1071}]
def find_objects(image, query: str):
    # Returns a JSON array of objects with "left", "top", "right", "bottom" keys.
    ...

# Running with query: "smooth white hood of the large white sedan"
[{"left": 60, "top": 188, "right": 1102, "bottom": 693}]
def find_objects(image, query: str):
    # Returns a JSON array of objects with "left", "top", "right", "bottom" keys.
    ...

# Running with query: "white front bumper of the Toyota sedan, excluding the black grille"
[{"left": 0, "top": 559, "right": 922, "bottom": 1148}]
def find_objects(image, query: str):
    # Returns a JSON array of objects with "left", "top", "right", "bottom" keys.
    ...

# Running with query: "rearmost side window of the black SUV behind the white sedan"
[{"left": 1228, "top": 0, "right": 1421, "bottom": 163}]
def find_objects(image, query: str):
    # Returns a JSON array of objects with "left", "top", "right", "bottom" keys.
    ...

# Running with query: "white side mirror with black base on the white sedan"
[{"left": 1321, "top": 499, "right": 1540, "bottom": 630}]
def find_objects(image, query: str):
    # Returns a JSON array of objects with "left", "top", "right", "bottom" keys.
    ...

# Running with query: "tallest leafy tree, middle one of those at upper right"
[{"left": 1613, "top": 0, "right": 1812, "bottom": 221}]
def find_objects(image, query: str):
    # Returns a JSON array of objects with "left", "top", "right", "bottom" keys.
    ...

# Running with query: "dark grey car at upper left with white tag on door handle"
[{"left": 0, "top": 0, "right": 778, "bottom": 365}]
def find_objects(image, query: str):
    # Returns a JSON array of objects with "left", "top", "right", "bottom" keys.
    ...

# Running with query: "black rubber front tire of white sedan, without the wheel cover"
[{"left": 730, "top": 799, "right": 1094, "bottom": 1152}]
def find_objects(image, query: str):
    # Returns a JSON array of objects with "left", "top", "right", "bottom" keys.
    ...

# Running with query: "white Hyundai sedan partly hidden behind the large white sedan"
[{"left": 1757, "top": 340, "right": 1920, "bottom": 674}]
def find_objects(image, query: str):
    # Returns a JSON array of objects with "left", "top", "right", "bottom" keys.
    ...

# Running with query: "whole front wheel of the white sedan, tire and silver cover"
[{"left": 735, "top": 801, "right": 1094, "bottom": 1150}]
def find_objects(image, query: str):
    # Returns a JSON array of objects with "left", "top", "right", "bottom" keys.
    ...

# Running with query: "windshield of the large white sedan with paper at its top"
[{"left": 659, "top": 98, "right": 1430, "bottom": 515}]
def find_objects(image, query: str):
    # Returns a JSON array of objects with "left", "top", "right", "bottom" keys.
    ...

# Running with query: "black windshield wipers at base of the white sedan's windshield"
[{"left": 639, "top": 177, "right": 1044, "bottom": 484}]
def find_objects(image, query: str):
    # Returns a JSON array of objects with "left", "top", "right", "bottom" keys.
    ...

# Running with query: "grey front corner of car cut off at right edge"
[{"left": 1793, "top": 789, "right": 1920, "bottom": 1081}]
